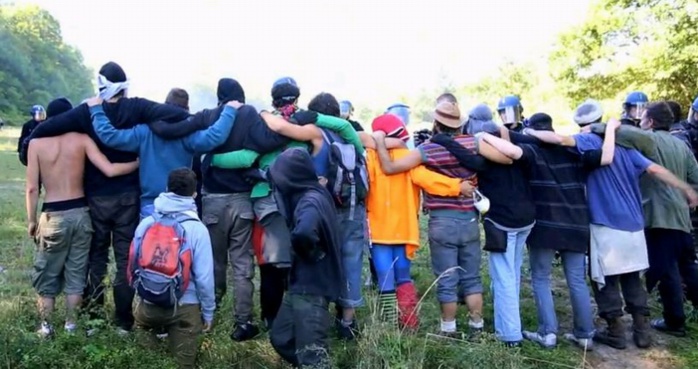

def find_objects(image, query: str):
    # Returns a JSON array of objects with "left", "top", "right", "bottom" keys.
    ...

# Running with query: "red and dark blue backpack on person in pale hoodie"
[{"left": 128, "top": 213, "right": 195, "bottom": 308}]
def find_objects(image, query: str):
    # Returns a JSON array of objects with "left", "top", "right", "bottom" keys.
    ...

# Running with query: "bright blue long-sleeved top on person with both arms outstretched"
[{"left": 90, "top": 105, "right": 237, "bottom": 208}]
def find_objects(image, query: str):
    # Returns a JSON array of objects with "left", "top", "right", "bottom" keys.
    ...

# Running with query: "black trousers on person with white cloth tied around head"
[{"left": 83, "top": 192, "right": 140, "bottom": 330}]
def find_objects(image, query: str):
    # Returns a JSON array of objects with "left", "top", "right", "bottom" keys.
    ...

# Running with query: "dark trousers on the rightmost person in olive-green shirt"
[{"left": 645, "top": 228, "right": 698, "bottom": 328}]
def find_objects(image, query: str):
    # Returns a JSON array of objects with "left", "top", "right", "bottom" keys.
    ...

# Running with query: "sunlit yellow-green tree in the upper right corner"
[{"left": 550, "top": 0, "right": 698, "bottom": 106}]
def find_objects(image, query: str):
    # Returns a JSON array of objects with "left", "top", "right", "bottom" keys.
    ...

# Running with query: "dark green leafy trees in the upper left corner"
[{"left": 0, "top": 6, "right": 92, "bottom": 124}]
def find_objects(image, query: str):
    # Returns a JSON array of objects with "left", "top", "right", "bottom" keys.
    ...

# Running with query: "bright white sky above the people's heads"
[{"left": 25, "top": 0, "right": 589, "bottom": 109}]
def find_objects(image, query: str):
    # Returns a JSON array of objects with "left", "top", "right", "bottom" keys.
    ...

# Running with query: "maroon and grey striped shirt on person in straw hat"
[{"left": 419, "top": 135, "right": 477, "bottom": 212}]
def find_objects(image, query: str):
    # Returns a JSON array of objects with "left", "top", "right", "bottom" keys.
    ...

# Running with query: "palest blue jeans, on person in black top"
[{"left": 490, "top": 229, "right": 531, "bottom": 342}]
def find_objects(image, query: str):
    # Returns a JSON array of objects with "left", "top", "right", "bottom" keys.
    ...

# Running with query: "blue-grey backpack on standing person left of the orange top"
[{"left": 320, "top": 129, "right": 368, "bottom": 219}]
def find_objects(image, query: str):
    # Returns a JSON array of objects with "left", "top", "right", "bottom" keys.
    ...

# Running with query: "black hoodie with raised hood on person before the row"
[{"left": 269, "top": 148, "right": 344, "bottom": 301}]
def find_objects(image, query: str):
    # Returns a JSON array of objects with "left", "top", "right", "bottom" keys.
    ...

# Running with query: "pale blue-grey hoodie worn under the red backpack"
[{"left": 136, "top": 192, "right": 216, "bottom": 323}]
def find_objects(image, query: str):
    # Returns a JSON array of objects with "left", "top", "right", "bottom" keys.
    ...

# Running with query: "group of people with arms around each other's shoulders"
[{"left": 18, "top": 62, "right": 698, "bottom": 368}]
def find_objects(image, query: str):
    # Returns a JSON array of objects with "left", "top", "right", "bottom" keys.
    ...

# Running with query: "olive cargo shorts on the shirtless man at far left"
[{"left": 32, "top": 207, "right": 94, "bottom": 297}]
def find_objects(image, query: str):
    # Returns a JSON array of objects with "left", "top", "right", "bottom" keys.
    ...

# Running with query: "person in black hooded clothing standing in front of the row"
[{"left": 269, "top": 148, "right": 343, "bottom": 368}]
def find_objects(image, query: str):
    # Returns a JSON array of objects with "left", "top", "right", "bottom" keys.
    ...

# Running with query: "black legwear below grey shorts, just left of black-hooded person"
[{"left": 259, "top": 264, "right": 289, "bottom": 321}]
